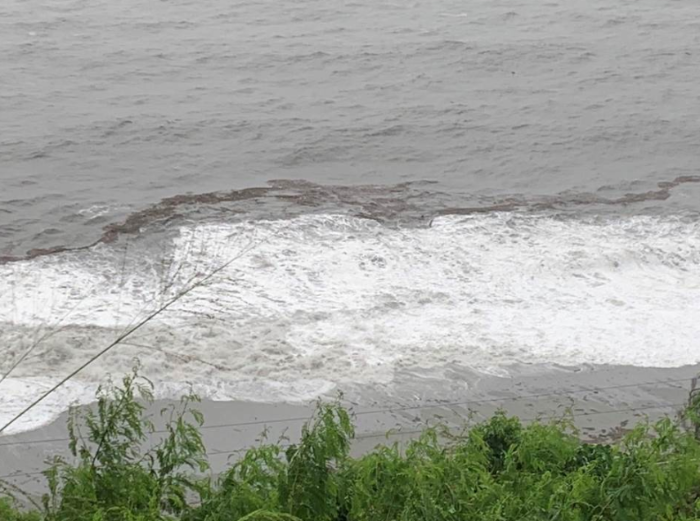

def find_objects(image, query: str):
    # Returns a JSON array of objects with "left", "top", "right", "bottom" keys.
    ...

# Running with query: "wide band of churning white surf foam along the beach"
[{"left": 0, "top": 214, "right": 700, "bottom": 432}]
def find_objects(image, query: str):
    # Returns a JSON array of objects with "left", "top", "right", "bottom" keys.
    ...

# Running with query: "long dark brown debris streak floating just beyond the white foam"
[{"left": 0, "top": 175, "right": 700, "bottom": 264}]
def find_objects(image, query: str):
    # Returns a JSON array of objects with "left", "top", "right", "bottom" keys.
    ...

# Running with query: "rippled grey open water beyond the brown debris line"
[{"left": 0, "top": 0, "right": 700, "bottom": 256}]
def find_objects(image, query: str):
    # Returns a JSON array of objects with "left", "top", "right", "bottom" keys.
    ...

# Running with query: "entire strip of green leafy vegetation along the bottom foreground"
[{"left": 0, "top": 366, "right": 700, "bottom": 521}]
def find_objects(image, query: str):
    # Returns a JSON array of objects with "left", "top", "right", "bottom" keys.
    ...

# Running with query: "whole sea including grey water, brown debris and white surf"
[{"left": 0, "top": 0, "right": 700, "bottom": 429}]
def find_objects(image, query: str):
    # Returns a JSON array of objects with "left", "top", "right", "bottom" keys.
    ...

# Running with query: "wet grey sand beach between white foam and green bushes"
[{"left": 0, "top": 364, "right": 700, "bottom": 494}]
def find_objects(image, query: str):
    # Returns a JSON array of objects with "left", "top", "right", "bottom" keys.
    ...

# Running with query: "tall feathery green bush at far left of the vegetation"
[{"left": 32, "top": 369, "right": 208, "bottom": 521}]
